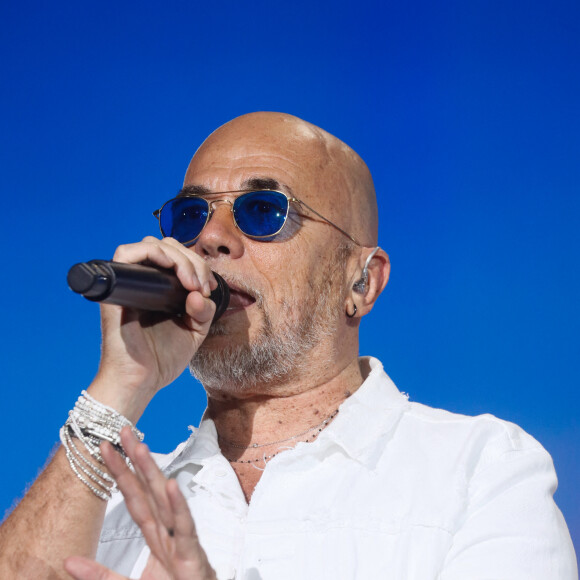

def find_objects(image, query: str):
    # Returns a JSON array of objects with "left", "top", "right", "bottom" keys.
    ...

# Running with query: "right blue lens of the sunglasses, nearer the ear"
[{"left": 233, "top": 191, "right": 288, "bottom": 238}]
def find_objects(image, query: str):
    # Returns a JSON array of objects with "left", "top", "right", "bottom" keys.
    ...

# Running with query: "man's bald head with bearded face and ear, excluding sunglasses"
[{"left": 183, "top": 112, "right": 388, "bottom": 397}]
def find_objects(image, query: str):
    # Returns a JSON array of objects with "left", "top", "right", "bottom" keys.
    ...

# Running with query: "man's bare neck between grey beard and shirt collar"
[{"left": 207, "top": 358, "right": 363, "bottom": 446}]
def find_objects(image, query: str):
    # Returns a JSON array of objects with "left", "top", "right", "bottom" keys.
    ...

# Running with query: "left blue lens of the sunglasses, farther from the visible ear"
[{"left": 159, "top": 197, "right": 208, "bottom": 244}]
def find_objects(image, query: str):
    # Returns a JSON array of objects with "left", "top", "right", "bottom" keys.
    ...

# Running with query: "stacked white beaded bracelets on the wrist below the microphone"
[{"left": 60, "top": 391, "right": 144, "bottom": 501}]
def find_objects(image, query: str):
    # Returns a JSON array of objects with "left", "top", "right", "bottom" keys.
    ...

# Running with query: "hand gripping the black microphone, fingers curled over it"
[{"left": 89, "top": 237, "right": 216, "bottom": 423}]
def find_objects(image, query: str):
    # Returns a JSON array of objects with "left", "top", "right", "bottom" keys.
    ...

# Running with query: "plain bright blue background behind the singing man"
[{"left": 0, "top": 0, "right": 580, "bottom": 546}]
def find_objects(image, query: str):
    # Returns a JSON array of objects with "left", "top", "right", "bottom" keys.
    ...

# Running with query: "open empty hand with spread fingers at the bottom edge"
[{"left": 64, "top": 428, "right": 217, "bottom": 580}]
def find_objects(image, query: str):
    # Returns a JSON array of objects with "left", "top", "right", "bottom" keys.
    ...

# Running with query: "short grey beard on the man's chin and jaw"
[{"left": 189, "top": 272, "right": 344, "bottom": 393}]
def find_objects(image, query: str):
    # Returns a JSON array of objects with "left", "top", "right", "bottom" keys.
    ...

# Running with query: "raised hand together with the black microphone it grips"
[{"left": 68, "top": 236, "right": 229, "bottom": 424}]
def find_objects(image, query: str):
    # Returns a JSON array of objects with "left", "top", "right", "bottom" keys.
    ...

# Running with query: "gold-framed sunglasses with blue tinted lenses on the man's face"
[{"left": 153, "top": 190, "right": 360, "bottom": 246}]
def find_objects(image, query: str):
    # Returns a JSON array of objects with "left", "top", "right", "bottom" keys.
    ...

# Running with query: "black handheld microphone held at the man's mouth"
[{"left": 67, "top": 260, "right": 230, "bottom": 323}]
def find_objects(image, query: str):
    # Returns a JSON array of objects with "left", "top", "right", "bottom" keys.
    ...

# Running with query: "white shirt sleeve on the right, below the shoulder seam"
[{"left": 438, "top": 424, "right": 578, "bottom": 580}]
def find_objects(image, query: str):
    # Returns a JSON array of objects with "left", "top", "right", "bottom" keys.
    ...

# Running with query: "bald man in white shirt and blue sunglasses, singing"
[{"left": 0, "top": 113, "right": 577, "bottom": 580}]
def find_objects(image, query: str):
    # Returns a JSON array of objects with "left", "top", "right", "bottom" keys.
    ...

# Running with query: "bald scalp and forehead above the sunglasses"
[{"left": 185, "top": 112, "right": 378, "bottom": 246}]
